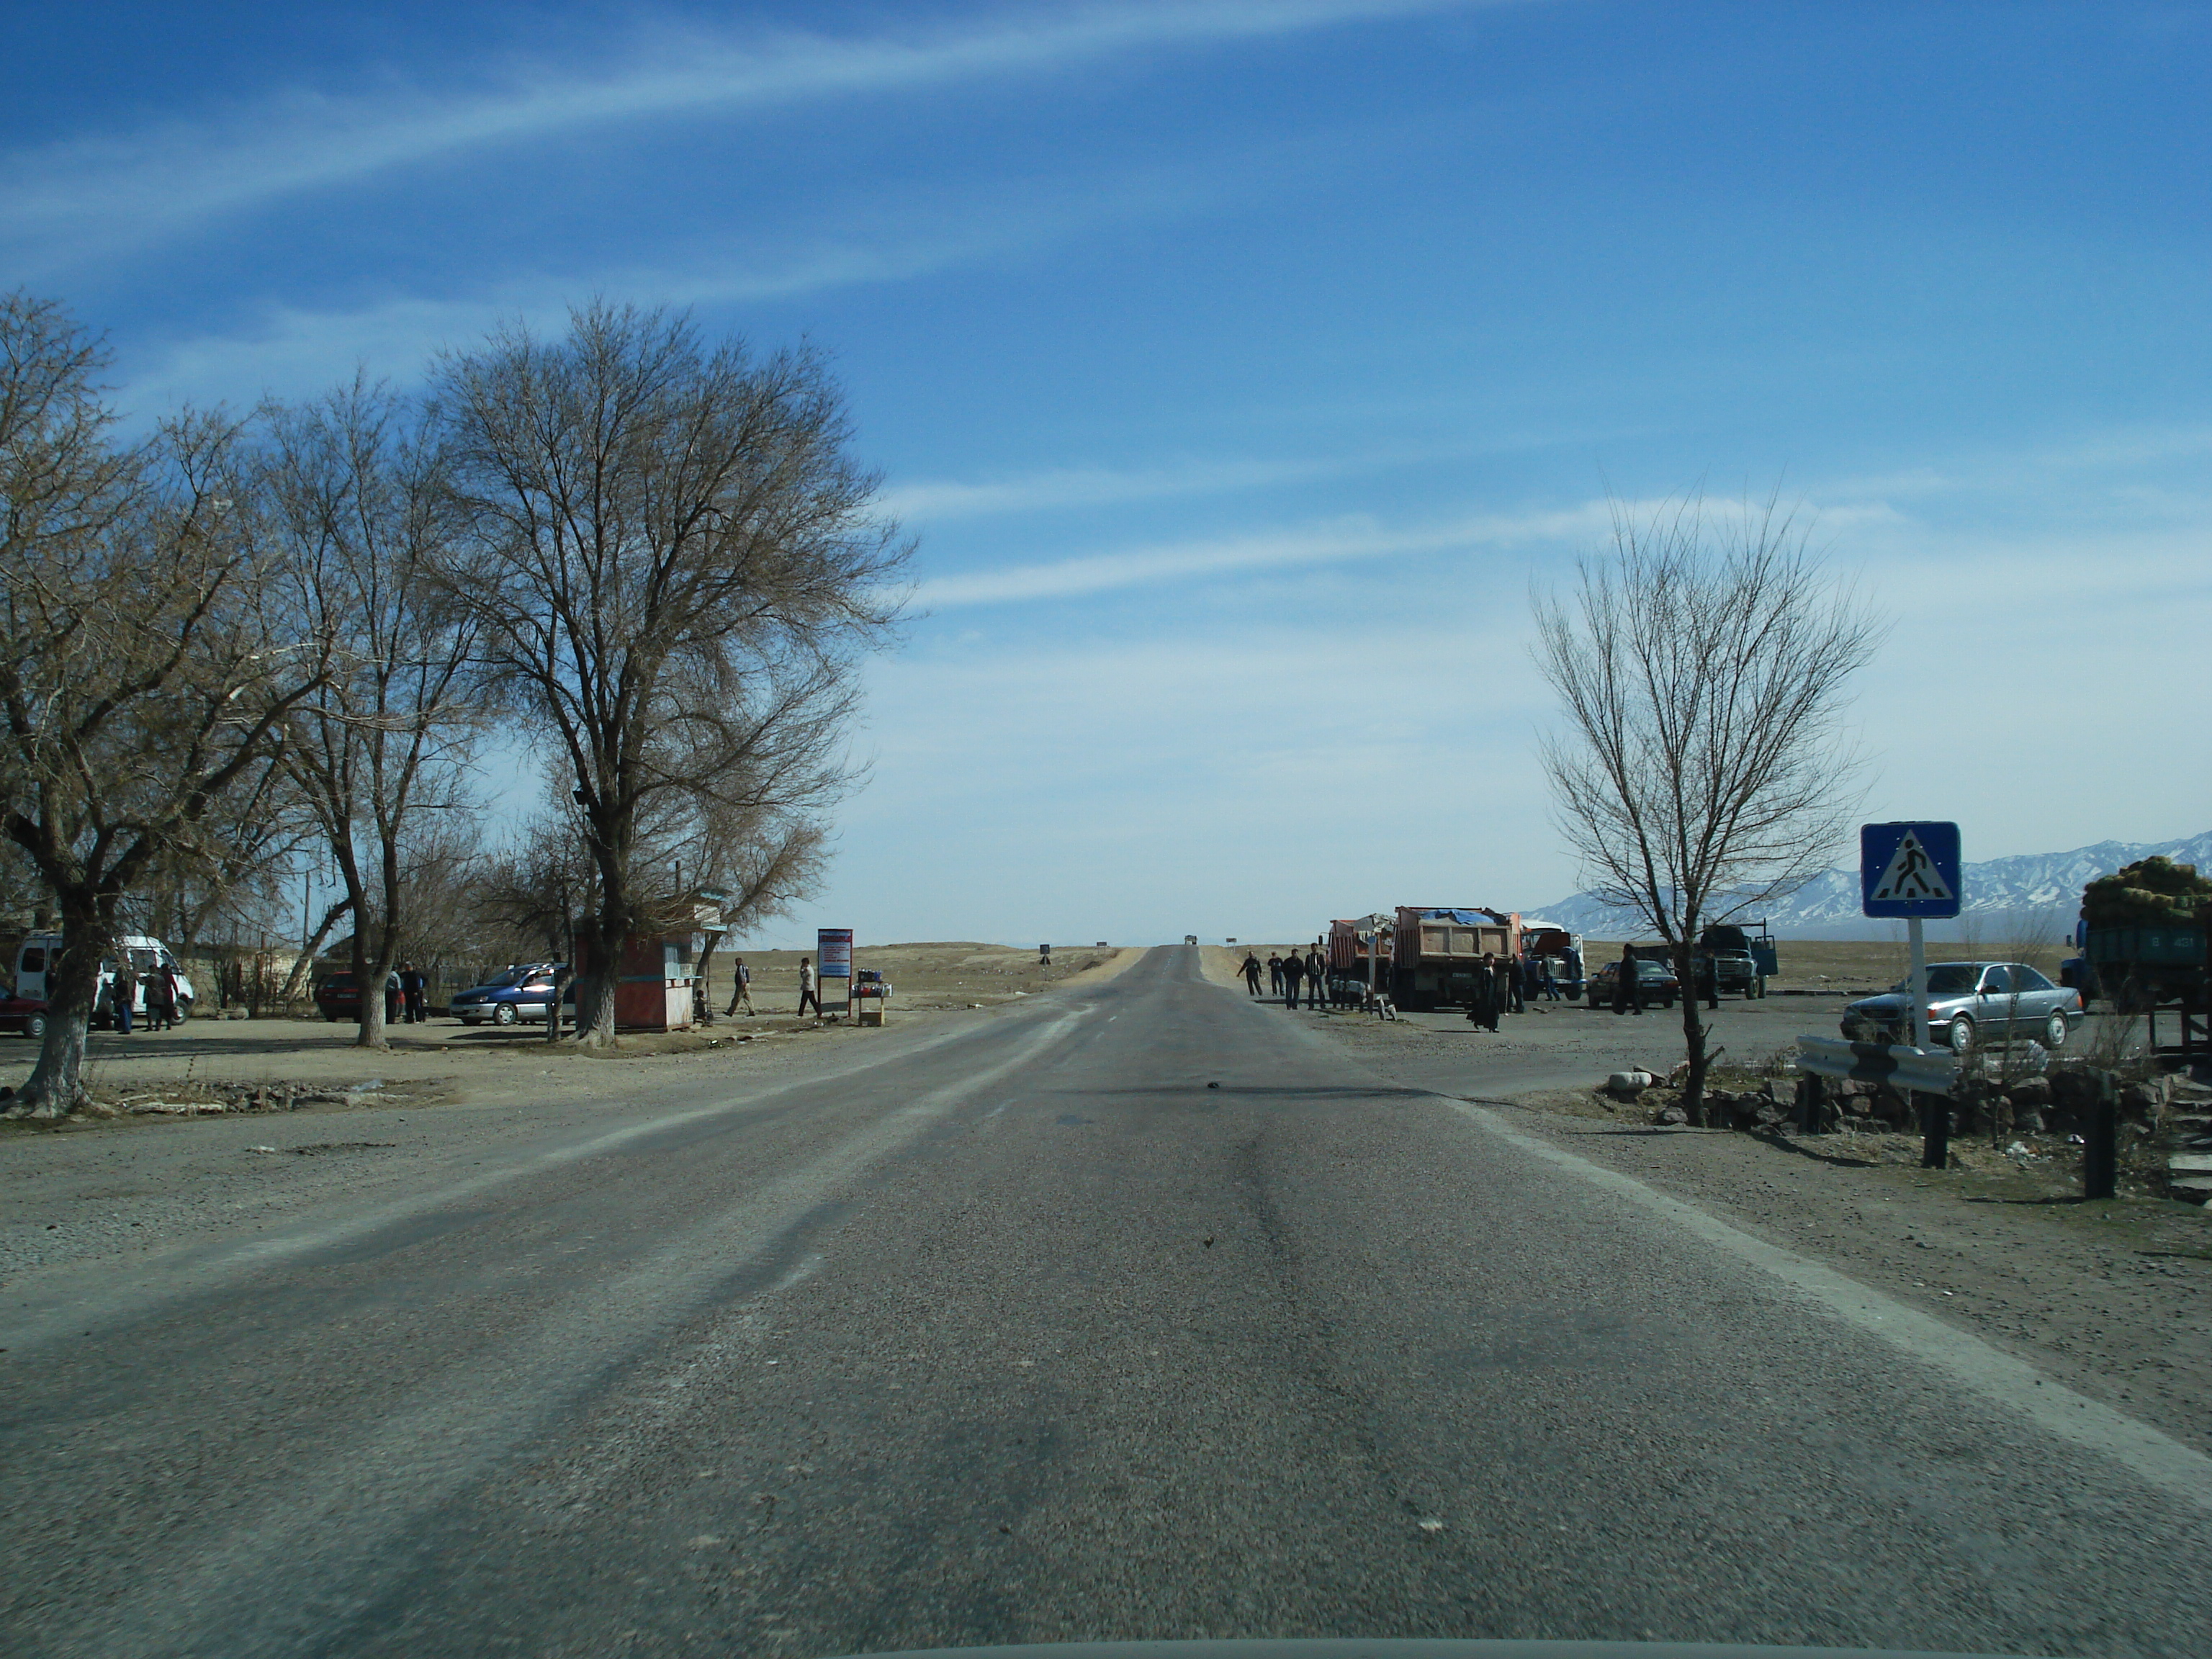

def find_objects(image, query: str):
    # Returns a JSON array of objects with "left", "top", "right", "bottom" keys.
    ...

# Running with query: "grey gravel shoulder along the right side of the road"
[{"left": 1283, "top": 1000, "right": 2212, "bottom": 1453}]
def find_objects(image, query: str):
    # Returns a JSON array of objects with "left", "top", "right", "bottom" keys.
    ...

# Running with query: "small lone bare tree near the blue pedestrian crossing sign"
[{"left": 1533, "top": 498, "right": 1882, "bottom": 1124}]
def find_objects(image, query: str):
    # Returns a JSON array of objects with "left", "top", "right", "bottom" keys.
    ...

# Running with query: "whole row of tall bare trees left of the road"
[{"left": 0, "top": 295, "right": 907, "bottom": 1115}]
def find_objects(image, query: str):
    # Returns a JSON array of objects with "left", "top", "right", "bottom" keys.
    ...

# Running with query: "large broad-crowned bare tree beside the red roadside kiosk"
[{"left": 440, "top": 303, "right": 907, "bottom": 1044}]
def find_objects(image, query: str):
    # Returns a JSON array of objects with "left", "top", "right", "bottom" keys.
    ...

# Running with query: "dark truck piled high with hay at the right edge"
[{"left": 2082, "top": 856, "right": 2212, "bottom": 1055}]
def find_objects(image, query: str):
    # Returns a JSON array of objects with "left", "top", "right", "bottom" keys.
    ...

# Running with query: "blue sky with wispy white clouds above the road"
[{"left": 0, "top": 0, "right": 2212, "bottom": 943}]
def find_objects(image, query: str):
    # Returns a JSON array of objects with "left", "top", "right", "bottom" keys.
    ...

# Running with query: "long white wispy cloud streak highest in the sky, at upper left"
[{"left": 0, "top": 0, "right": 1506, "bottom": 270}]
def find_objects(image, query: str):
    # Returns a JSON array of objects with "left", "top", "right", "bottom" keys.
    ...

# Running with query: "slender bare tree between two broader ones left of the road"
[{"left": 261, "top": 378, "right": 485, "bottom": 1048}]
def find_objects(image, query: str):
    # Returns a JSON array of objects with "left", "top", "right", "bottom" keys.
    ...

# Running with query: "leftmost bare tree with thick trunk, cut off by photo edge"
[{"left": 0, "top": 297, "right": 325, "bottom": 1117}]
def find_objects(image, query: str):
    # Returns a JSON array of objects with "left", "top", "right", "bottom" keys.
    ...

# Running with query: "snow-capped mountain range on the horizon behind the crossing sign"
[{"left": 1537, "top": 830, "right": 2212, "bottom": 938}]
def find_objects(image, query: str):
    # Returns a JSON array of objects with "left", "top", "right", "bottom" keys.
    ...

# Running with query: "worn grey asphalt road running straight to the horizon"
[{"left": 0, "top": 949, "right": 2212, "bottom": 1659}]
